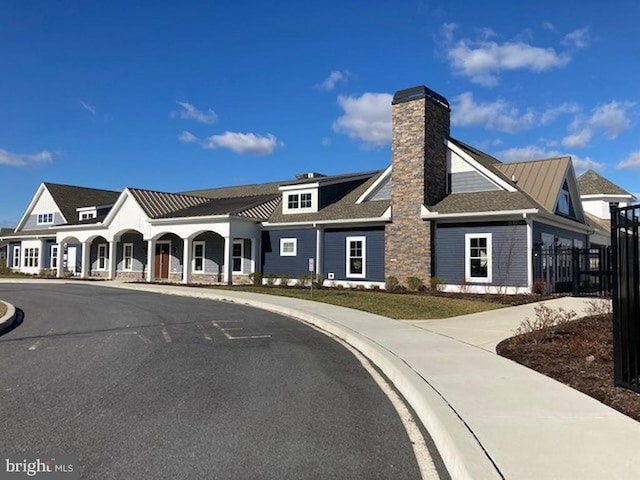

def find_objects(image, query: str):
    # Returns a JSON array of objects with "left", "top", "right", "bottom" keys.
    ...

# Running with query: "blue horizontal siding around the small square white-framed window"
[{"left": 262, "top": 228, "right": 316, "bottom": 278}]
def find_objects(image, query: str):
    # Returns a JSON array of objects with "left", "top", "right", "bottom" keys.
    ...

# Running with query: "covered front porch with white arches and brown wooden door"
[{"left": 57, "top": 222, "right": 260, "bottom": 284}]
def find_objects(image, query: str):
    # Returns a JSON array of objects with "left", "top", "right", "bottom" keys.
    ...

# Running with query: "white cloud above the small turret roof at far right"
[{"left": 562, "top": 101, "right": 635, "bottom": 148}]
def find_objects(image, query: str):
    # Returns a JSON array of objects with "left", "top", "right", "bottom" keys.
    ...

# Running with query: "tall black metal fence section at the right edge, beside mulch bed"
[{"left": 611, "top": 205, "right": 640, "bottom": 392}]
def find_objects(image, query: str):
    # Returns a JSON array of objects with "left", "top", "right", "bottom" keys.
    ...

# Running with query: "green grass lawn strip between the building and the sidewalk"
[{"left": 216, "top": 286, "right": 505, "bottom": 320}]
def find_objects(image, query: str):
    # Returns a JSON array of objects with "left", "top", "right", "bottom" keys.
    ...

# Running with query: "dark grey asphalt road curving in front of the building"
[{"left": 0, "top": 284, "right": 420, "bottom": 479}]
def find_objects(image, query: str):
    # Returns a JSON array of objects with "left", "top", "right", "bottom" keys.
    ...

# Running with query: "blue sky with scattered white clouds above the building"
[{"left": 0, "top": 0, "right": 640, "bottom": 226}]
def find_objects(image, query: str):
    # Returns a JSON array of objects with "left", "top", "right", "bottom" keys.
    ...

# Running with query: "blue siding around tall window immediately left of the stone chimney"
[{"left": 322, "top": 227, "right": 384, "bottom": 282}]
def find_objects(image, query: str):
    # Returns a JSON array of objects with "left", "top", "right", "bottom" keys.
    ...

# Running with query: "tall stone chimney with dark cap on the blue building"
[{"left": 385, "top": 86, "right": 451, "bottom": 285}]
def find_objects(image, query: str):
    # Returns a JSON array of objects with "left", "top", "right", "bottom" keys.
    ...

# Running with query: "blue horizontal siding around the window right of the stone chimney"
[{"left": 435, "top": 222, "right": 529, "bottom": 286}]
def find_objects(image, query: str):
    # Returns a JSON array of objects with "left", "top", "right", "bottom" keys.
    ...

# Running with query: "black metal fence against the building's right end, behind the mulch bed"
[{"left": 533, "top": 246, "right": 612, "bottom": 296}]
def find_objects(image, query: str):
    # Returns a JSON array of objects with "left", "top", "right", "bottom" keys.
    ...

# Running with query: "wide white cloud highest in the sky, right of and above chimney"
[{"left": 442, "top": 24, "right": 571, "bottom": 86}]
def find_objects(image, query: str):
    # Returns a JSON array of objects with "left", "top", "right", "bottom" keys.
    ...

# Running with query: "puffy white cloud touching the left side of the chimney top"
[{"left": 333, "top": 93, "right": 393, "bottom": 148}]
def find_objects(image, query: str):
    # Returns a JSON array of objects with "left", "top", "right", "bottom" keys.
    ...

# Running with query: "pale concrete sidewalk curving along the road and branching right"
[{"left": 1, "top": 282, "right": 640, "bottom": 480}]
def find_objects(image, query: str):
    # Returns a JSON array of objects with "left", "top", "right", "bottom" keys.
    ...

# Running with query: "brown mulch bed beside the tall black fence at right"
[{"left": 496, "top": 314, "right": 640, "bottom": 421}]
